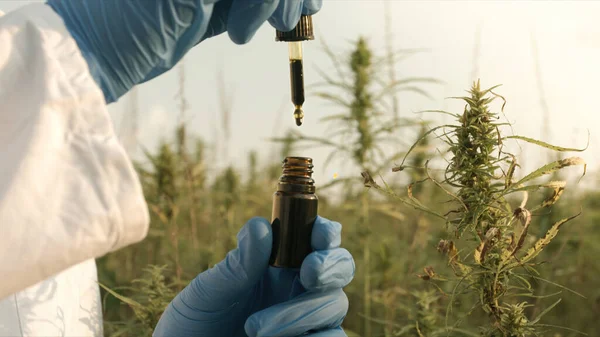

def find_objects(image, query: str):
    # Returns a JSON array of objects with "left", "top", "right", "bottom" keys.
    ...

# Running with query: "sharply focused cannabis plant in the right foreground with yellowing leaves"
[{"left": 363, "top": 82, "right": 586, "bottom": 337}]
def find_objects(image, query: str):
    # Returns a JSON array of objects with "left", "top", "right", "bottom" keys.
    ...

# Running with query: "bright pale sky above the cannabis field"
[{"left": 0, "top": 0, "right": 600, "bottom": 192}]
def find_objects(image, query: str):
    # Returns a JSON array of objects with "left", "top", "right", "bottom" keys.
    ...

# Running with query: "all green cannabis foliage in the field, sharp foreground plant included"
[{"left": 98, "top": 39, "right": 600, "bottom": 337}]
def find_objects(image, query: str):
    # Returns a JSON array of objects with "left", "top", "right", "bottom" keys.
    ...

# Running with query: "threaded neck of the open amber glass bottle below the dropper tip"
[{"left": 277, "top": 157, "right": 315, "bottom": 193}]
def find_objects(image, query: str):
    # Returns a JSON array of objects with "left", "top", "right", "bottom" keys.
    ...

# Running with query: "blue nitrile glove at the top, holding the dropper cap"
[{"left": 47, "top": 0, "right": 323, "bottom": 103}]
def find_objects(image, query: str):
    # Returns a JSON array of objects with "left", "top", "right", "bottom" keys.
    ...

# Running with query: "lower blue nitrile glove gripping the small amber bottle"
[{"left": 153, "top": 217, "right": 355, "bottom": 337}]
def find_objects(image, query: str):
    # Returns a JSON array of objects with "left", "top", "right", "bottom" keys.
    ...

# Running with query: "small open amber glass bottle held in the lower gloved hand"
[{"left": 270, "top": 157, "right": 319, "bottom": 268}]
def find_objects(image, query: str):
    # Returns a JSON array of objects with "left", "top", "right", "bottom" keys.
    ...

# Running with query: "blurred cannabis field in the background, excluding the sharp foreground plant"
[{"left": 98, "top": 34, "right": 600, "bottom": 337}]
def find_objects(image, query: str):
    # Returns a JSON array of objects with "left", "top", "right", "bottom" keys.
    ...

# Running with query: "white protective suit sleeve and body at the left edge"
[{"left": 0, "top": 3, "right": 149, "bottom": 337}]
